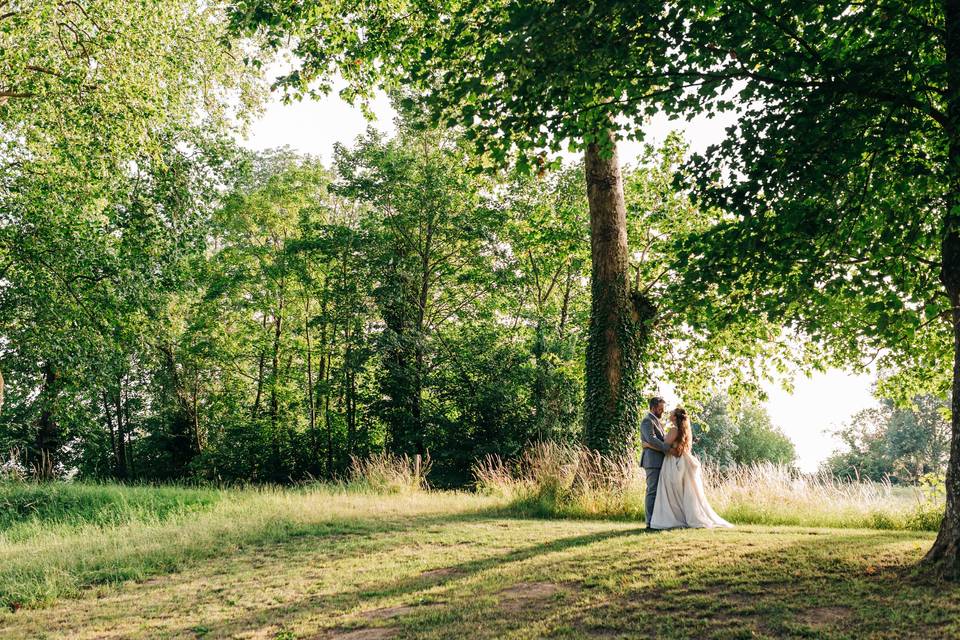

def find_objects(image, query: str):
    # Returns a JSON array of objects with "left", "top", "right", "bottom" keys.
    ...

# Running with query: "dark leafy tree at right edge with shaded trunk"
[{"left": 663, "top": 0, "right": 960, "bottom": 578}]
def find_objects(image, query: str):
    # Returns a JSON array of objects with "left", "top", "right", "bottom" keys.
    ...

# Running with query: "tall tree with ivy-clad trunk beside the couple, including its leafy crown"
[{"left": 231, "top": 0, "right": 792, "bottom": 454}]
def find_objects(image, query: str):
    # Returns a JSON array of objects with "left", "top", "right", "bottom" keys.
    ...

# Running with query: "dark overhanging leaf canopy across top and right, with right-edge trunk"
[{"left": 227, "top": 0, "right": 960, "bottom": 576}]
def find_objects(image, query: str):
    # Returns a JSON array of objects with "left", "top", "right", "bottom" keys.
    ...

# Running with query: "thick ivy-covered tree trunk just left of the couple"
[{"left": 584, "top": 134, "right": 639, "bottom": 455}]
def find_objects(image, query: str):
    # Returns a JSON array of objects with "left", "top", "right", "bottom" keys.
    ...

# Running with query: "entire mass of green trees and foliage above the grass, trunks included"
[{"left": 0, "top": 0, "right": 960, "bottom": 575}]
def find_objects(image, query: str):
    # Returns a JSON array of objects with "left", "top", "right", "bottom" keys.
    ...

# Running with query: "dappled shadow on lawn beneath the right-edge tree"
[{"left": 571, "top": 531, "right": 960, "bottom": 639}]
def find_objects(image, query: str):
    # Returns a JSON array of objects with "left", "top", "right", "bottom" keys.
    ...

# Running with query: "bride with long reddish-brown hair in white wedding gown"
[{"left": 644, "top": 407, "right": 733, "bottom": 529}]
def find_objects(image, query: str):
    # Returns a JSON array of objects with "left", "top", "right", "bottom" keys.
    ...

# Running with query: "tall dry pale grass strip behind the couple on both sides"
[{"left": 473, "top": 443, "right": 942, "bottom": 531}]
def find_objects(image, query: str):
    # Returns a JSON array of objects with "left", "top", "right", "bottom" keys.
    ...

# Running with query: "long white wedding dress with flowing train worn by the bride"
[{"left": 650, "top": 444, "right": 733, "bottom": 529}]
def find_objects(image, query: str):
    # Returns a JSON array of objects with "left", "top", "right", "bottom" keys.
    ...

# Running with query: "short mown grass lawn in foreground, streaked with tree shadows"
[{"left": 0, "top": 493, "right": 960, "bottom": 640}]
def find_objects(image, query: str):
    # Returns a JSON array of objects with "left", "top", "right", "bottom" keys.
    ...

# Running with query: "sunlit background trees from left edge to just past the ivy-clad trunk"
[{"left": 0, "top": 0, "right": 777, "bottom": 490}]
